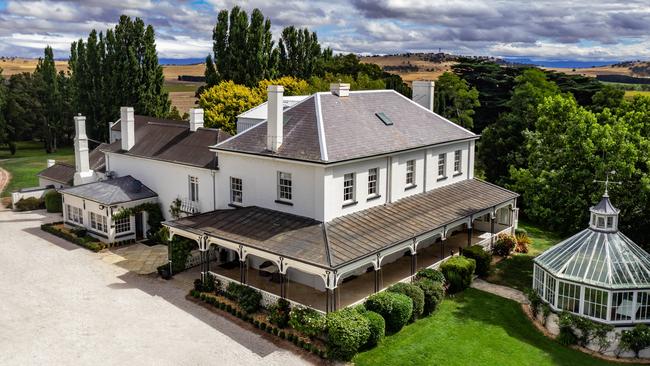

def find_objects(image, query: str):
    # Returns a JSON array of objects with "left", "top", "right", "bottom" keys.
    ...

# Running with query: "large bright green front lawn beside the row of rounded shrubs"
[{"left": 354, "top": 289, "right": 624, "bottom": 366}]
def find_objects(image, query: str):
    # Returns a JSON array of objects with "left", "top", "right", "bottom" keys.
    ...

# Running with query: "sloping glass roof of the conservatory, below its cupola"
[{"left": 535, "top": 228, "right": 650, "bottom": 289}]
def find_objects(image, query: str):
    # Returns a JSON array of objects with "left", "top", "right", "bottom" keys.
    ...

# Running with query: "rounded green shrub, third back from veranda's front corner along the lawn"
[{"left": 364, "top": 291, "right": 413, "bottom": 333}]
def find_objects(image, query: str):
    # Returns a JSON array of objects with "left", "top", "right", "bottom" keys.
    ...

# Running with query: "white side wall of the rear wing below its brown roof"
[{"left": 106, "top": 153, "right": 219, "bottom": 220}]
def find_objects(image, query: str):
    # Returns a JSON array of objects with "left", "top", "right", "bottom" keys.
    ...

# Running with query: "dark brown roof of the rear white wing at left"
[{"left": 104, "top": 116, "right": 230, "bottom": 168}]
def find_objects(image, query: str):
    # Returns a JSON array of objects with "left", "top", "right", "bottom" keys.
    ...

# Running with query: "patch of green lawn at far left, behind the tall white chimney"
[{"left": 0, "top": 141, "right": 74, "bottom": 197}]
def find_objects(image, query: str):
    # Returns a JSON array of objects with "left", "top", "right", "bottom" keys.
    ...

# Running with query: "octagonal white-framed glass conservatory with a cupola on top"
[{"left": 533, "top": 191, "right": 650, "bottom": 326}]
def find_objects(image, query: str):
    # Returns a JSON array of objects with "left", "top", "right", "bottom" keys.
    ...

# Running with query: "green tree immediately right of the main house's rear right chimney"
[{"left": 433, "top": 72, "right": 480, "bottom": 129}]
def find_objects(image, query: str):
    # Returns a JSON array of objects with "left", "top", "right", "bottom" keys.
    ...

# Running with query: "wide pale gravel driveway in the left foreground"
[{"left": 0, "top": 209, "right": 311, "bottom": 366}]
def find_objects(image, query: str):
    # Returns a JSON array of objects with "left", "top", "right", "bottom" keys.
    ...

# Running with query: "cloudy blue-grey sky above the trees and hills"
[{"left": 0, "top": 0, "right": 650, "bottom": 60}]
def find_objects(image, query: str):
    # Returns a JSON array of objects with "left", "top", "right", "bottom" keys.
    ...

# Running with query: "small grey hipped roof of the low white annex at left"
[{"left": 60, "top": 175, "right": 158, "bottom": 205}]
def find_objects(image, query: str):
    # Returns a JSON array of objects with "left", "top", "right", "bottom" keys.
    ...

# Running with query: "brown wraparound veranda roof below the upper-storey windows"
[{"left": 166, "top": 179, "right": 517, "bottom": 268}]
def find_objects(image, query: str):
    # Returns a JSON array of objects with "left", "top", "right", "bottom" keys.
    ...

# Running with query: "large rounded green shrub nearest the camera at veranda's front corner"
[{"left": 327, "top": 308, "right": 370, "bottom": 361}]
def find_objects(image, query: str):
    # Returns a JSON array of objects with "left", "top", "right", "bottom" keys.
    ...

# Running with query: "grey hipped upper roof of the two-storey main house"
[{"left": 215, "top": 90, "right": 478, "bottom": 163}]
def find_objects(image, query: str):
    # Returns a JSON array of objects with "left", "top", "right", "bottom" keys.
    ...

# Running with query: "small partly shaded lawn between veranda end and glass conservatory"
[{"left": 487, "top": 222, "right": 561, "bottom": 291}]
